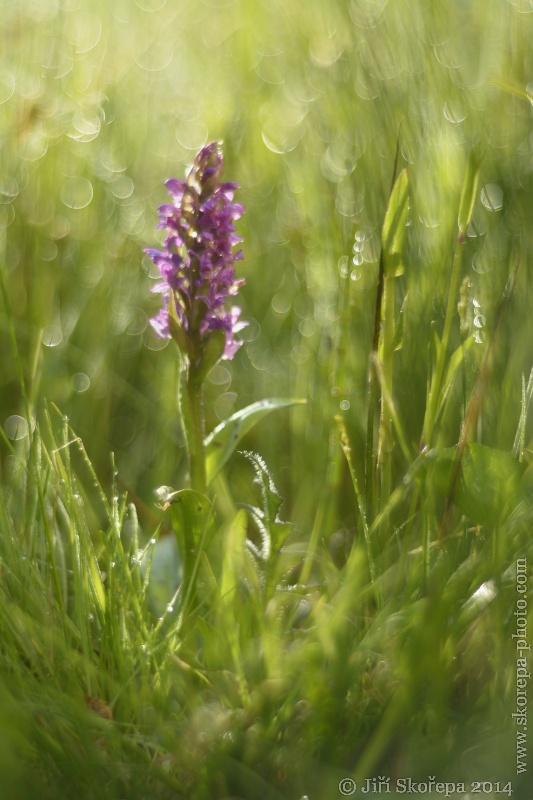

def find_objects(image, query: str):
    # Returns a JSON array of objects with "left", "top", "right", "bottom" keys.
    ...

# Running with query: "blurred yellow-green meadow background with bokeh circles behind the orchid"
[{"left": 0, "top": 0, "right": 533, "bottom": 531}]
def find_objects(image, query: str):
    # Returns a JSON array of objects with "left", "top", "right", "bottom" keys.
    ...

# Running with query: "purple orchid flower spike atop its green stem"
[{"left": 145, "top": 142, "right": 247, "bottom": 366}]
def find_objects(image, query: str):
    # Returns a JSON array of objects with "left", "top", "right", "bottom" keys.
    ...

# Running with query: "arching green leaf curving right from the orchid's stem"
[{"left": 205, "top": 398, "right": 307, "bottom": 485}]
